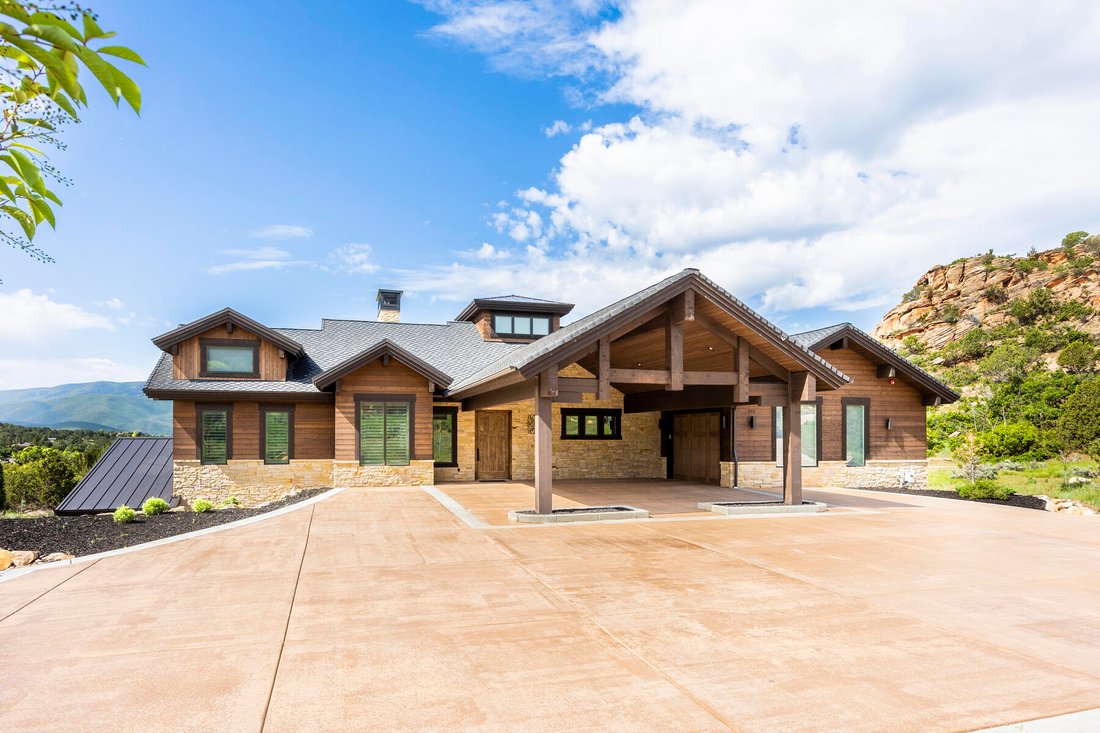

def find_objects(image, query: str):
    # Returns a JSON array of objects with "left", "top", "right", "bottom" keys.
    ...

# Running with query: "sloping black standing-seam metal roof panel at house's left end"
[{"left": 54, "top": 438, "right": 172, "bottom": 514}]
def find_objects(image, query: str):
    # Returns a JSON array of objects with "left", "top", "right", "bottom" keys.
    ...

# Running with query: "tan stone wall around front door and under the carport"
[{"left": 436, "top": 364, "right": 666, "bottom": 482}]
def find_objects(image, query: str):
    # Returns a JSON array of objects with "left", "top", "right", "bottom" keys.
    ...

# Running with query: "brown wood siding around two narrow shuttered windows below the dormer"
[{"left": 172, "top": 401, "right": 334, "bottom": 460}]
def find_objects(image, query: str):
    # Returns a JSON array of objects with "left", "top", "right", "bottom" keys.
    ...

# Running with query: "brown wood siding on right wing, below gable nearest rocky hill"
[{"left": 735, "top": 349, "right": 927, "bottom": 461}]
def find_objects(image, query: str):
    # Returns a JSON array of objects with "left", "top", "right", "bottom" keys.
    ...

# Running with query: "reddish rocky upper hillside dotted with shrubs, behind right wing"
[{"left": 875, "top": 232, "right": 1100, "bottom": 353}]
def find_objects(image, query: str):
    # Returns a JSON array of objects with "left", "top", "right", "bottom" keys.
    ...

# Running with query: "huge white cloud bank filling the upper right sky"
[{"left": 406, "top": 0, "right": 1100, "bottom": 317}]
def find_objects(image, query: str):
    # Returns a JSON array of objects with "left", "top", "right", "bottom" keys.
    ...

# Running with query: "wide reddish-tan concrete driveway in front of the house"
[{"left": 0, "top": 489, "right": 1100, "bottom": 731}]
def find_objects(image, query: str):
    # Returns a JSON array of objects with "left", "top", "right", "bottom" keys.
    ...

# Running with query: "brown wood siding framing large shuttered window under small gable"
[{"left": 334, "top": 359, "right": 431, "bottom": 461}]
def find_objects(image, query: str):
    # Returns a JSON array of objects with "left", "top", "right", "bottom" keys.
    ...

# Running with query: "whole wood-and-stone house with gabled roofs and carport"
[{"left": 145, "top": 270, "right": 958, "bottom": 513}]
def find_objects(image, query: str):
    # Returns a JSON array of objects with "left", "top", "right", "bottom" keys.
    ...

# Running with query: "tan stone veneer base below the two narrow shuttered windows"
[{"left": 172, "top": 459, "right": 332, "bottom": 506}]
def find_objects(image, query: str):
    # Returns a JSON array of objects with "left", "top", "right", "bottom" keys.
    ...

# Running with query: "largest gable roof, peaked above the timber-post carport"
[{"left": 450, "top": 269, "right": 850, "bottom": 394}]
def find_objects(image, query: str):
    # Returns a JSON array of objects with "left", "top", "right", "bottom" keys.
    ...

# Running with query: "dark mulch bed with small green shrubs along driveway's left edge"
[{"left": 0, "top": 489, "right": 328, "bottom": 557}]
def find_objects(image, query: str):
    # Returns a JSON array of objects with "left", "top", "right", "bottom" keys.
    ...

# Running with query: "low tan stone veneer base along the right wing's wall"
[{"left": 722, "top": 460, "right": 928, "bottom": 490}]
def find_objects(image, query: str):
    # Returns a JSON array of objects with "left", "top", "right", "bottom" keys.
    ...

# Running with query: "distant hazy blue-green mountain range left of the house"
[{"left": 0, "top": 382, "right": 172, "bottom": 435}]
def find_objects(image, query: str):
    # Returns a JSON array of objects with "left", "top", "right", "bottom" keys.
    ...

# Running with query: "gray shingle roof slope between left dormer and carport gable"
[{"left": 145, "top": 319, "right": 520, "bottom": 395}]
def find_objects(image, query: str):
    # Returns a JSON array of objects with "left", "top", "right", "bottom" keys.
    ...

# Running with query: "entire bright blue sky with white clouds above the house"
[{"left": 0, "top": 0, "right": 1100, "bottom": 389}]
